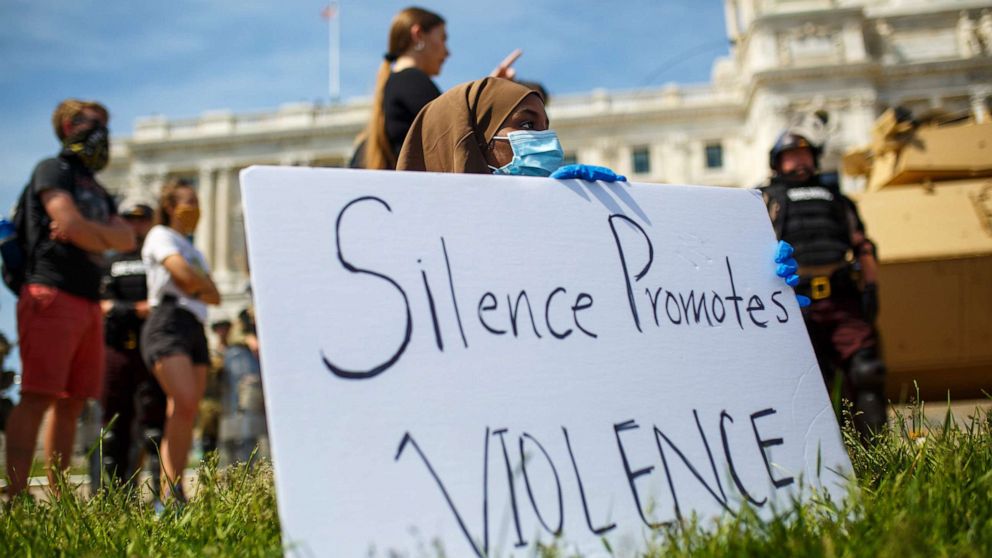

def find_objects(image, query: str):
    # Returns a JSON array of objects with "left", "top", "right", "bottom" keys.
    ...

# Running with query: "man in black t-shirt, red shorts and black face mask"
[{"left": 6, "top": 99, "right": 135, "bottom": 497}]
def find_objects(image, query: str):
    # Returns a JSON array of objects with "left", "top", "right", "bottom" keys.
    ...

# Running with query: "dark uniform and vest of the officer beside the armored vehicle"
[{"left": 762, "top": 173, "right": 885, "bottom": 440}]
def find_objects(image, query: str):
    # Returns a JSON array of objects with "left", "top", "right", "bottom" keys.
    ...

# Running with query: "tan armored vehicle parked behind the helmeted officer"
[{"left": 844, "top": 110, "right": 992, "bottom": 401}]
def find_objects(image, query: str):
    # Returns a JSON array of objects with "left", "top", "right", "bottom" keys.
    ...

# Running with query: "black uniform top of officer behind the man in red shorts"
[{"left": 103, "top": 248, "right": 148, "bottom": 349}]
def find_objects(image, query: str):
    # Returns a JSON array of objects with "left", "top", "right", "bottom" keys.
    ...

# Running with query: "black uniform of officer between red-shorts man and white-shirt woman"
[{"left": 92, "top": 248, "right": 165, "bottom": 486}]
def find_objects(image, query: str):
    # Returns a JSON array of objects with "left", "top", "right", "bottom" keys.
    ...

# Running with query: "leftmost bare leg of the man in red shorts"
[{"left": 6, "top": 393, "right": 55, "bottom": 498}]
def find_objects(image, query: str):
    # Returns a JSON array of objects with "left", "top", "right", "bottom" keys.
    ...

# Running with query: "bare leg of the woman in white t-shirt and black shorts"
[{"left": 154, "top": 355, "right": 207, "bottom": 497}]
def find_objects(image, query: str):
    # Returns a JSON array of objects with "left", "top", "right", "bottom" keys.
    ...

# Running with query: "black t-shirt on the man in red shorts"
[{"left": 25, "top": 154, "right": 117, "bottom": 300}]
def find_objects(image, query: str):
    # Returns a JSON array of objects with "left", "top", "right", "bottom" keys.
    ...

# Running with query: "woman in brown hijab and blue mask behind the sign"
[{"left": 396, "top": 77, "right": 626, "bottom": 181}]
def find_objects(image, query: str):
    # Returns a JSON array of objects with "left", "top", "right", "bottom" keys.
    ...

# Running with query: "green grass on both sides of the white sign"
[{"left": 0, "top": 406, "right": 992, "bottom": 558}]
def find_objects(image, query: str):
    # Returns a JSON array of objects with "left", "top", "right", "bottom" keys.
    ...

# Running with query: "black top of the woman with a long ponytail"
[{"left": 382, "top": 68, "right": 441, "bottom": 155}]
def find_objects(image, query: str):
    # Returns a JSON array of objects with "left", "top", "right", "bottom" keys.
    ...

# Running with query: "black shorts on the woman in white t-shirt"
[{"left": 141, "top": 300, "right": 210, "bottom": 370}]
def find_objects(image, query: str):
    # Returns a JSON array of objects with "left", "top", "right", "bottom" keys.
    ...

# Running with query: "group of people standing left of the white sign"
[{"left": 5, "top": 99, "right": 268, "bottom": 502}]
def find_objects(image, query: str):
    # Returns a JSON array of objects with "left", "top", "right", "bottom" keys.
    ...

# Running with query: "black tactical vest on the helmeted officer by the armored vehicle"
[{"left": 763, "top": 176, "right": 851, "bottom": 266}]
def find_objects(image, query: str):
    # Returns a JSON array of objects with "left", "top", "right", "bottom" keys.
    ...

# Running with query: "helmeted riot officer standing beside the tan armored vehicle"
[{"left": 762, "top": 129, "right": 886, "bottom": 438}]
